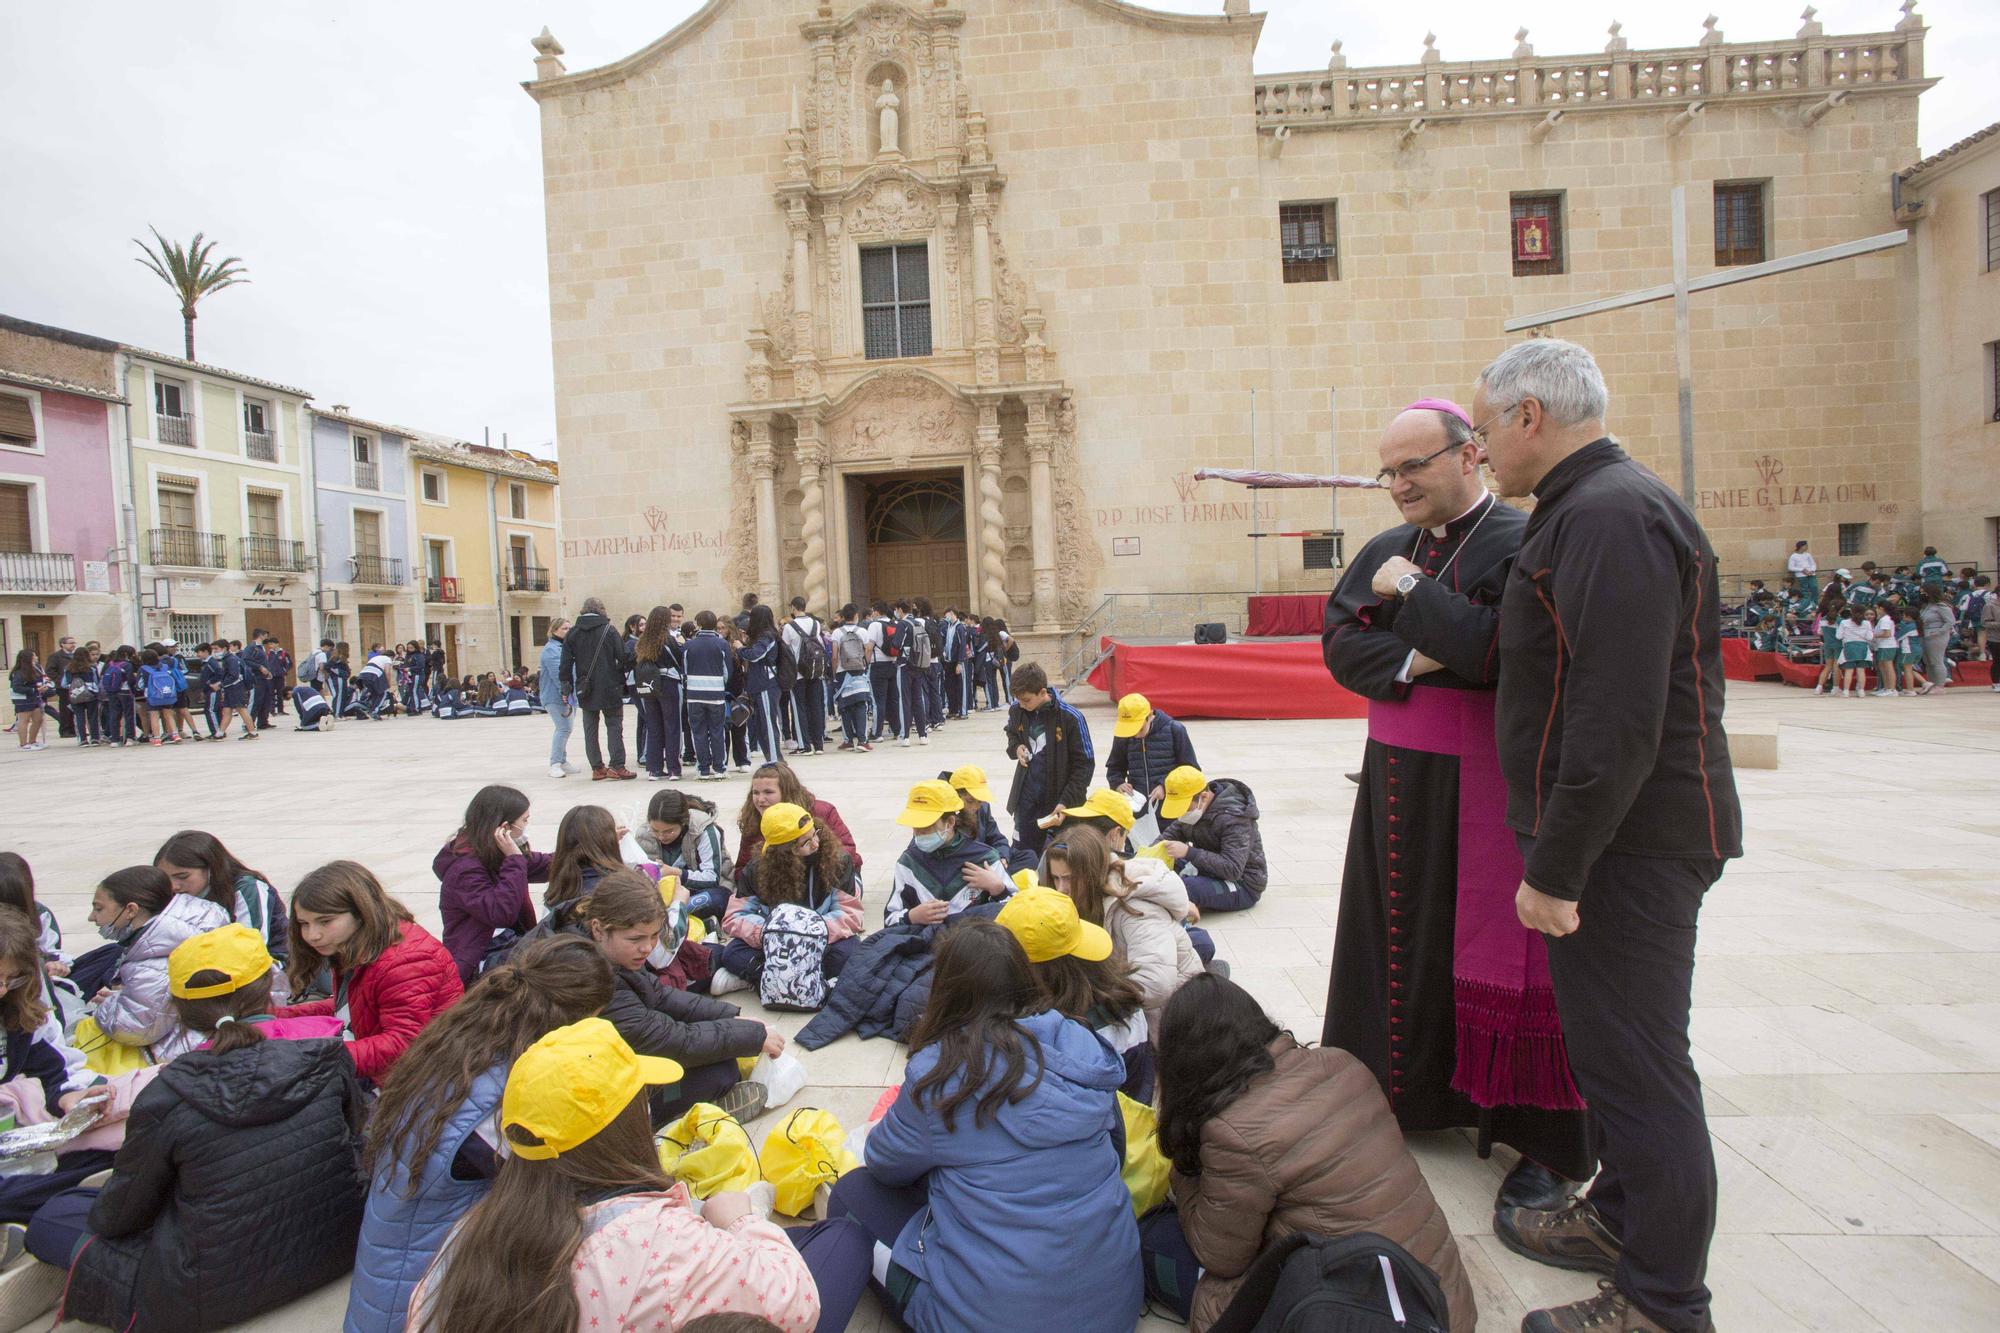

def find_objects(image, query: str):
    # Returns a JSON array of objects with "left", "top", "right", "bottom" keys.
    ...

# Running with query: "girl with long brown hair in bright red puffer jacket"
[{"left": 278, "top": 861, "right": 464, "bottom": 1083}]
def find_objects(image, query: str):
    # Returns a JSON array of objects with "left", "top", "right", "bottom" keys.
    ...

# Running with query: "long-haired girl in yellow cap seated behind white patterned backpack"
[{"left": 708, "top": 801, "right": 862, "bottom": 995}]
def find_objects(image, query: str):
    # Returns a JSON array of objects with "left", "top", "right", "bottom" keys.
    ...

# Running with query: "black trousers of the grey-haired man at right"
[{"left": 1520, "top": 839, "right": 1722, "bottom": 1333}]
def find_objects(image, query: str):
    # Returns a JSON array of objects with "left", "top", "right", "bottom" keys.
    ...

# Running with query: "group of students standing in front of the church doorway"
[{"left": 540, "top": 594, "right": 1020, "bottom": 781}]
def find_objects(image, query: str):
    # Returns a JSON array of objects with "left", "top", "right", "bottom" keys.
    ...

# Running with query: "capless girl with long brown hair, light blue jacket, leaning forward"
[{"left": 346, "top": 935, "right": 612, "bottom": 1333}]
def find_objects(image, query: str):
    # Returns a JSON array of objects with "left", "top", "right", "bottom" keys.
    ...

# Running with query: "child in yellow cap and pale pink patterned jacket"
[{"left": 410, "top": 1019, "right": 870, "bottom": 1333}]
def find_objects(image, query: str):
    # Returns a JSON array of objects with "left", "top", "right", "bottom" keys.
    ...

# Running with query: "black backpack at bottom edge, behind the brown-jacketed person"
[{"left": 1210, "top": 1231, "right": 1452, "bottom": 1333}]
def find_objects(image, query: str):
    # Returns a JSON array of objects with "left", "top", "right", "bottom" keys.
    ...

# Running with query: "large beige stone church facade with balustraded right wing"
[{"left": 526, "top": 0, "right": 1930, "bottom": 634}]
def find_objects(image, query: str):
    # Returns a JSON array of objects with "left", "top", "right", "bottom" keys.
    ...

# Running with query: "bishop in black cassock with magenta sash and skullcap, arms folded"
[{"left": 1322, "top": 398, "right": 1594, "bottom": 1207}]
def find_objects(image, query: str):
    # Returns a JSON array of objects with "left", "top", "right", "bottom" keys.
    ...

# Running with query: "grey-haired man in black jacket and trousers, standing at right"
[{"left": 1472, "top": 338, "right": 1742, "bottom": 1333}]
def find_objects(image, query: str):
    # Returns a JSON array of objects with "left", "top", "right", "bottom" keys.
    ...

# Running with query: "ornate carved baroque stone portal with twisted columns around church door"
[{"left": 728, "top": 2, "right": 1098, "bottom": 630}]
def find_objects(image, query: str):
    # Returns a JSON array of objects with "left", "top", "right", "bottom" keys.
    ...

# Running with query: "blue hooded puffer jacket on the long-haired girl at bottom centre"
[{"left": 866, "top": 1013, "right": 1144, "bottom": 1333}]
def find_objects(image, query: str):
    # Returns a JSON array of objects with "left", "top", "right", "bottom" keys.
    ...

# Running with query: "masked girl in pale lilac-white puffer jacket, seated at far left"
[{"left": 90, "top": 865, "right": 230, "bottom": 1065}]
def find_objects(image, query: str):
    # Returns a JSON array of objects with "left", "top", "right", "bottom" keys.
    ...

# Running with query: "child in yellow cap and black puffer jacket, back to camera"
[{"left": 28, "top": 925, "right": 368, "bottom": 1329}]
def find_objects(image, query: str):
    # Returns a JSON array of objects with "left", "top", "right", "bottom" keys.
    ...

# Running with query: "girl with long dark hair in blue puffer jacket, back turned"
[{"left": 830, "top": 921, "right": 1144, "bottom": 1333}]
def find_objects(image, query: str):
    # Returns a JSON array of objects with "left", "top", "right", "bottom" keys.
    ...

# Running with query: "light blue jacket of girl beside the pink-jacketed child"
[{"left": 342, "top": 1067, "right": 506, "bottom": 1333}]
